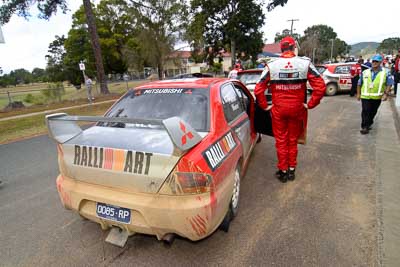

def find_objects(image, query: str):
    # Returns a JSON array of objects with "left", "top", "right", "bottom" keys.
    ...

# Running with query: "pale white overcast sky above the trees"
[{"left": 0, "top": 0, "right": 400, "bottom": 73}]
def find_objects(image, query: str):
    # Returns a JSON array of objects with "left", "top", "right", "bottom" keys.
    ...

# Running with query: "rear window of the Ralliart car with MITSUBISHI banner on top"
[{"left": 106, "top": 88, "right": 209, "bottom": 131}]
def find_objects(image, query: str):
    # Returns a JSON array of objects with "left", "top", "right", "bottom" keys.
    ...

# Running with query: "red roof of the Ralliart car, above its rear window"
[{"left": 135, "top": 78, "right": 230, "bottom": 89}]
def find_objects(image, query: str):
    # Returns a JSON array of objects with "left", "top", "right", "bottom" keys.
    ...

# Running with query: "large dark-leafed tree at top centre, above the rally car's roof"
[{"left": 187, "top": 0, "right": 287, "bottom": 66}]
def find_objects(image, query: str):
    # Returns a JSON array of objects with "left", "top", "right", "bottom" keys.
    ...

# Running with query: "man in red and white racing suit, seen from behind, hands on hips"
[{"left": 255, "top": 36, "right": 326, "bottom": 183}]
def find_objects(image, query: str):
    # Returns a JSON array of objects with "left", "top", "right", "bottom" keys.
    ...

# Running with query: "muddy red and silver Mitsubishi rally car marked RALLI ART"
[{"left": 46, "top": 78, "right": 257, "bottom": 246}]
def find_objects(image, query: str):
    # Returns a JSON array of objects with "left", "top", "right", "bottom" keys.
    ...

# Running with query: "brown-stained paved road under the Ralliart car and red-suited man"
[{"left": 0, "top": 95, "right": 379, "bottom": 266}]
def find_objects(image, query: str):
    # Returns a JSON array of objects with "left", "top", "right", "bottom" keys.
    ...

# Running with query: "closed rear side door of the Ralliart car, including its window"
[{"left": 220, "top": 83, "right": 254, "bottom": 160}]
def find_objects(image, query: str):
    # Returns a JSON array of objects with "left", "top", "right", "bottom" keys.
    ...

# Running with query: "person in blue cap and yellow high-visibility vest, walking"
[{"left": 357, "top": 54, "right": 393, "bottom": 134}]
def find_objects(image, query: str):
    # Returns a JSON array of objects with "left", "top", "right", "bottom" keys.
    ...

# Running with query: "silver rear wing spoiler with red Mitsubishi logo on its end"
[{"left": 46, "top": 113, "right": 202, "bottom": 152}]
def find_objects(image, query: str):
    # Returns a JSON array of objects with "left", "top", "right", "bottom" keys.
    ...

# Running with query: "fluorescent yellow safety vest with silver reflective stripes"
[{"left": 361, "top": 69, "right": 387, "bottom": 99}]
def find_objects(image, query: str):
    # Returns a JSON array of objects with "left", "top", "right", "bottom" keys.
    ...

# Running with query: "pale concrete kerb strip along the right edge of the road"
[{"left": 376, "top": 99, "right": 400, "bottom": 266}]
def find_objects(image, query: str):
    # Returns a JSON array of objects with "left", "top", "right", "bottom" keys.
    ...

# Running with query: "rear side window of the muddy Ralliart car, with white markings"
[{"left": 221, "top": 83, "right": 244, "bottom": 122}]
